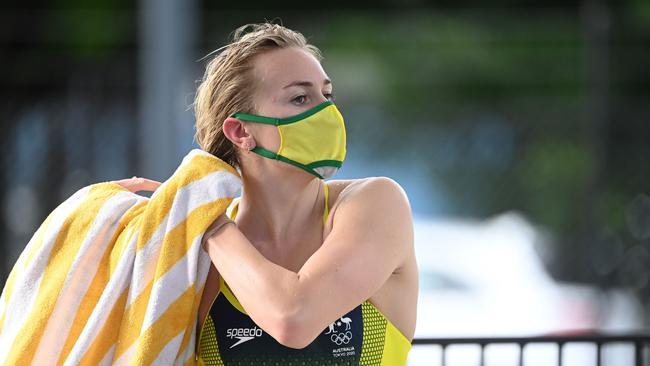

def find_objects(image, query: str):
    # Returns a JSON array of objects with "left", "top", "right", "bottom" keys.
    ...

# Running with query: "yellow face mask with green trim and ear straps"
[{"left": 233, "top": 101, "right": 345, "bottom": 179}]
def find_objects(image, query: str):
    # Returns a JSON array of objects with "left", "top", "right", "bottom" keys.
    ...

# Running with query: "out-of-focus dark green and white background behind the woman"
[{"left": 0, "top": 0, "right": 650, "bottom": 364}]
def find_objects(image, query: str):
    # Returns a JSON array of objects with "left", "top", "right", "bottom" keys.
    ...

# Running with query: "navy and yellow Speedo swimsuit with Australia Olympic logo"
[{"left": 197, "top": 184, "right": 411, "bottom": 366}]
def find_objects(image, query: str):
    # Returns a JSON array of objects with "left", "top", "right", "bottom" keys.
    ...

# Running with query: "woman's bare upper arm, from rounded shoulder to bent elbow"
[{"left": 284, "top": 177, "right": 413, "bottom": 342}]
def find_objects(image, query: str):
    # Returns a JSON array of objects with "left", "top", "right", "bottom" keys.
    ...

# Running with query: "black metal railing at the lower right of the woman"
[{"left": 412, "top": 333, "right": 650, "bottom": 366}]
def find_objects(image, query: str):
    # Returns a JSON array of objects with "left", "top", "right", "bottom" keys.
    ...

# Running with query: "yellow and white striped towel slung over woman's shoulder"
[{"left": 0, "top": 149, "right": 241, "bottom": 365}]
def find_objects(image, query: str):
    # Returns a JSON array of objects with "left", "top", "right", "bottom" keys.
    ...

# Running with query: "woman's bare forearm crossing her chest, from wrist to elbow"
[{"left": 206, "top": 224, "right": 304, "bottom": 342}]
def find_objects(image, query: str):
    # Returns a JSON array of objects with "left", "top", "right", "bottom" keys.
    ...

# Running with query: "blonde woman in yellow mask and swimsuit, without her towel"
[{"left": 123, "top": 23, "right": 418, "bottom": 365}]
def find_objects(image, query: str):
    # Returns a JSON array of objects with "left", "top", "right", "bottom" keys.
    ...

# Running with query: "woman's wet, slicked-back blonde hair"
[{"left": 193, "top": 22, "right": 322, "bottom": 168}]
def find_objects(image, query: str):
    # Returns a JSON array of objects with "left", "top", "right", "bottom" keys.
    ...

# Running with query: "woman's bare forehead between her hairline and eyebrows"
[{"left": 253, "top": 47, "right": 327, "bottom": 90}]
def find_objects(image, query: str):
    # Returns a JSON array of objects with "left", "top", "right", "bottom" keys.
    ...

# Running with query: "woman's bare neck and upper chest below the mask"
[{"left": 236, "top": 162, "right": 324, "bottom": 246}]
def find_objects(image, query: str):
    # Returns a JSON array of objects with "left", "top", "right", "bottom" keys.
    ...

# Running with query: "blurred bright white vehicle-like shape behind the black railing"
[{"left": 408, "top": 213, "right": 642, "bottom": 366}]
